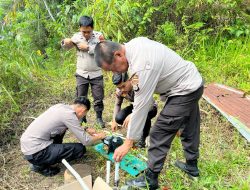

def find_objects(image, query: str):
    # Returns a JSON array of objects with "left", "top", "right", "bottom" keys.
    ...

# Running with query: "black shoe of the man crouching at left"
[{"left": 30, "top": 164, "right": 60, "bottom": 177}]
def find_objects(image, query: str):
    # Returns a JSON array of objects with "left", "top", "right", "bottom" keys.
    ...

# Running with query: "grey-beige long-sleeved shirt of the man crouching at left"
[{"left": 20, "top": 104, "right": 92, "bottom": 155}]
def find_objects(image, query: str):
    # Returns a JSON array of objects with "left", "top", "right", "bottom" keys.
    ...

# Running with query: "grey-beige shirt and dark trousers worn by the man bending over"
[{"left": 125, "top": 37, "right": 203, "bottom": 172}]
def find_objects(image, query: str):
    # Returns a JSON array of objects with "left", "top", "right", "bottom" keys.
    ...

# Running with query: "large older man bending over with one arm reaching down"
[{"left": 95, "top": 37, "right": 203, "bottom": 189}]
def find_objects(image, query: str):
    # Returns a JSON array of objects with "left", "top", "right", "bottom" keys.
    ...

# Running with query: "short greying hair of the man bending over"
[{"left": 94, "top": 40, "right": 122, "bottom": 67}]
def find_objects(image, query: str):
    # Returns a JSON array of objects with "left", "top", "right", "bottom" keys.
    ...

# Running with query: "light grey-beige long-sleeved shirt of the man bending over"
[{"left": 125, "top": 37, "right": 203, "bottom": 140}]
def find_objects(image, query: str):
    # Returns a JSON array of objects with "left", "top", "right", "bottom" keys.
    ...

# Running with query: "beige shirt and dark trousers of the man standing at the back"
[{"left": 63, "top": 31, "right": 104, "bottom": 112}]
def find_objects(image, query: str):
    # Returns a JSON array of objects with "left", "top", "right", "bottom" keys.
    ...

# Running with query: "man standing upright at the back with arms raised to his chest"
[{"left": 62, "top": 16, "right": 105, "bottom": 127}]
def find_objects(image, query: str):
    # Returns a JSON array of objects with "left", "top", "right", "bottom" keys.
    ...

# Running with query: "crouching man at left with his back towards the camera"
[{"left": 20, "top": 96, "right": 105, "bottom": 176}]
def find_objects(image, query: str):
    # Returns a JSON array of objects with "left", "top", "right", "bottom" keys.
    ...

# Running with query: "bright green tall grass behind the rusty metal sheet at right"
[{"left": 181, "top": 37, "right": 250, "bottom": 93}]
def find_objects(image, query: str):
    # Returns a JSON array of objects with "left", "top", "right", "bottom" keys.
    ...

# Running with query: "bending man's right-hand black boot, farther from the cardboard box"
[{"left": 175, "top": 160, "right": 199, "bottom": 179}]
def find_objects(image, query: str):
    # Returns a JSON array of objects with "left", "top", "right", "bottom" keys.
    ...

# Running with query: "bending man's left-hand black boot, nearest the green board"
[{"left": 126, "top": 168, "right": 159, "bottom": 190}]
